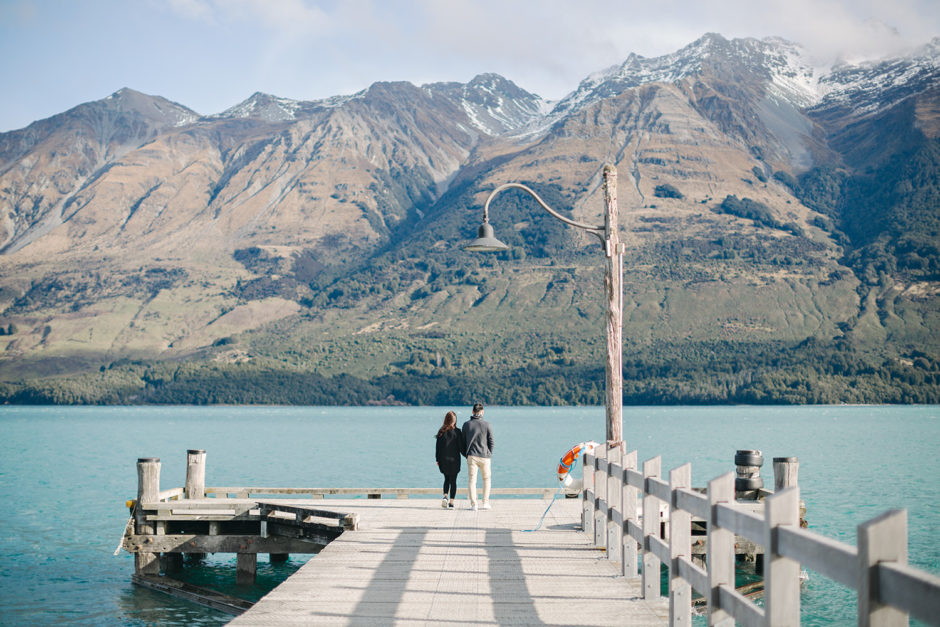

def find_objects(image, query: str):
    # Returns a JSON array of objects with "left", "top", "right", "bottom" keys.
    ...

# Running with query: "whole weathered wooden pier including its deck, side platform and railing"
[{"left": 123, "top": 446, "right": 940, "bottom": 627}]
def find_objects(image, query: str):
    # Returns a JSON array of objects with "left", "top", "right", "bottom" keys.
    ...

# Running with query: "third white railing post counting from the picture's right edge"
[{"left": 706, "top": 472, "right": 734, "bottom": 627}]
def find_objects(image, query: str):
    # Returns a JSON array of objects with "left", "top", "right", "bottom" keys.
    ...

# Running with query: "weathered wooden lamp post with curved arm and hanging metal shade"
[{"left": 463, "top": 164, "right": 623, "bottom": 446}]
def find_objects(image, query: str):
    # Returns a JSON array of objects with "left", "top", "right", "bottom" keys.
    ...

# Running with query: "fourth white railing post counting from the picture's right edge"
[{"left": 669, "top": 464, "right": 692, "bottom": 627}]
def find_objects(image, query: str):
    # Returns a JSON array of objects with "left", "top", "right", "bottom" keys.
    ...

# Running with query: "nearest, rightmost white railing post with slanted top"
[{"left": 858, "top": 509, "right": 908, "bottom": 627}]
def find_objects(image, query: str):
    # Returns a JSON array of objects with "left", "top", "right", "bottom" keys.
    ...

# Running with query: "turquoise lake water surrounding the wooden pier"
[{"left": 0, "top": 406, "right": 940, "bottom": 626}]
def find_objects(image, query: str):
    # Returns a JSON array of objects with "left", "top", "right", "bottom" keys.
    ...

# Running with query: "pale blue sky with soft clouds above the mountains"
[{"left": 0, "top": 0, "right": 940, "bottom": 132}]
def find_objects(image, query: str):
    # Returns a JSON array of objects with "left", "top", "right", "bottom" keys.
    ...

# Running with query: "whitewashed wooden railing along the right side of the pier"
[{"left": 582, "top": 447, "right": 940, "bottom": 627}]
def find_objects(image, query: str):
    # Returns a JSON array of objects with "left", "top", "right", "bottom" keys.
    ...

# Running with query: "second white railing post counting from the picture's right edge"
[{"left": 763, "top": 486, "right": 800, "bottom": 627}]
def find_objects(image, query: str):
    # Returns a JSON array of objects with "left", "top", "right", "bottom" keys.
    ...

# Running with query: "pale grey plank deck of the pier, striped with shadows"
[{"left": 231, "top": 499, "right": 669, "bottom": 626}]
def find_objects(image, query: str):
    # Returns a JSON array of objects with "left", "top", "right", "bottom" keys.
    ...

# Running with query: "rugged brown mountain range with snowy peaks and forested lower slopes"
[{"left": 0, "top": 34, "right": 940, "bottom": 404}]
